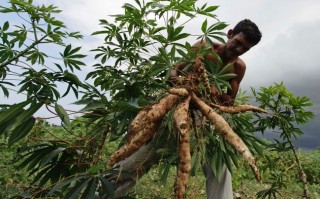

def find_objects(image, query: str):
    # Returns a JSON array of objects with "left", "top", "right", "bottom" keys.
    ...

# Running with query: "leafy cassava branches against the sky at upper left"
[{"left": 0, "top": 0, "right": 85, "bottom": 148}]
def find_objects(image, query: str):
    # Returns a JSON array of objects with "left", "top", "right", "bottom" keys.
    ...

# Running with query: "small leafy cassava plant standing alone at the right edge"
[{"left": 253, "top": 83, "right": 315, "bottom": 198}]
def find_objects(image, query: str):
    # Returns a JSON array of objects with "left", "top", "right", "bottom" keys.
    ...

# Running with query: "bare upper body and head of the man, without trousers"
[{"left": 171, "top": 19, "right": 262, "bottom": 105}]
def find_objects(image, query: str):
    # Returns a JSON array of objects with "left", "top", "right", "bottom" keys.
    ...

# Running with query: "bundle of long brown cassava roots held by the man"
[{"left": 108, "top": 56, "right": 266, "bottom": 199}]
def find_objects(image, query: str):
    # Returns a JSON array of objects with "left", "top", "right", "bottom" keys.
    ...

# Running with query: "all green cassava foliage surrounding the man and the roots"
[{"left": 0, "top": 0, "right": 313, "bottom": 198}]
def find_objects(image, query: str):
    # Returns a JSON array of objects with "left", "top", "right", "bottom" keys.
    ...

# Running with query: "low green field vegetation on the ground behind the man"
[{"left": 0, "top": 123, "right": 320, "bottom": 199}]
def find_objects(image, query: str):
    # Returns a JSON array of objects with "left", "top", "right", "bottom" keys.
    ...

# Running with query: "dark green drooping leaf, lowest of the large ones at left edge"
[{"left": 8, "top": 117, "right": 36, "bottom": 146}]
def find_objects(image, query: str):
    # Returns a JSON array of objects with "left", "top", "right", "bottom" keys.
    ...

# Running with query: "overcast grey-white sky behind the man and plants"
[{"left": 0, "top": 0, "right": 320, "bottom": 148}]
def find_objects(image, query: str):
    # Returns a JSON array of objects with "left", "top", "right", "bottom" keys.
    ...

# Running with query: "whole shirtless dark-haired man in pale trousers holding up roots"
[{"left": 111, "top": 19, "right": 262, "bottom": 199}]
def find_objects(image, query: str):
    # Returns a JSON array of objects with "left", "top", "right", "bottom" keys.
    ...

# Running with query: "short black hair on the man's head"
[{"left": 233, "top": 19, "right": 262, "bottom": 45}]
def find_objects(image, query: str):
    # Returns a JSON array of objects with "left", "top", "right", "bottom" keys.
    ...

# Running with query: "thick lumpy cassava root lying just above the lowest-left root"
[{"left": 127, "top": 94, "right": 179, "bottom": 142}]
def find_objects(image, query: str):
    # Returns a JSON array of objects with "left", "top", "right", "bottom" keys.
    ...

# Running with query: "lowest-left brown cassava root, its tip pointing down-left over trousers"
[{"left": 108, "top": 123, "right": 158, "bottom": 167}]
